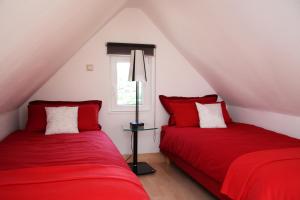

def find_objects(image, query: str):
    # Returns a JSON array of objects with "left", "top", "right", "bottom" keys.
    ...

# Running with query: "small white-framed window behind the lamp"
[{"left": 111, "top": 55, "right": 152, "bottom": 111}]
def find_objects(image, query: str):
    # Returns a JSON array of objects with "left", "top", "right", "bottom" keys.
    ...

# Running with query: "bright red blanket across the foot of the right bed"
[{"left": 221, "top": 147, "right": 300, "bottom": 200}]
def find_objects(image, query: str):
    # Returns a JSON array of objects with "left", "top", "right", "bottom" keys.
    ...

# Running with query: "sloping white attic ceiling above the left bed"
[{"left": 0, "top": 0, "right": 126, "bottom": 113}]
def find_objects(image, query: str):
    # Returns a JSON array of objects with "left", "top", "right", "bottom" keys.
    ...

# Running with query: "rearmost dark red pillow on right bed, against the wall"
[{"left": 159, "top": 94, "right": 218, "bottom": 126}]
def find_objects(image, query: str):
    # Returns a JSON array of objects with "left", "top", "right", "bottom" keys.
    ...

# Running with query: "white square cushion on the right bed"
[{"left": 196, "top": 103, "right": 227, "bottom": 128}]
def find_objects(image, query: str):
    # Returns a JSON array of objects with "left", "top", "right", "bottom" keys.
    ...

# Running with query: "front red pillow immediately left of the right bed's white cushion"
[{"left": 169, "top": 101, "right": 199, "bottom": 127}]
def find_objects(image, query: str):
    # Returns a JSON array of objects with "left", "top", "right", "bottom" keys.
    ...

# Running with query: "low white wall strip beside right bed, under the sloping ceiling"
[{"left": 229, "top": 106, "right": 300, "bottom": 139}]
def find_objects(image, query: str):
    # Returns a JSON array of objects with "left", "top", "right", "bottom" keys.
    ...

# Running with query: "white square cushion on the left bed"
[{"left": 45, "top": 106, "right": 79, "bottom": 135}]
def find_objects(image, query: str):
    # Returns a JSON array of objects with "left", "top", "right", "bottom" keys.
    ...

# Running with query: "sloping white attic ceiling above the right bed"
[{"left": 133, "top": 0, "right": 300, "bottom": 116}]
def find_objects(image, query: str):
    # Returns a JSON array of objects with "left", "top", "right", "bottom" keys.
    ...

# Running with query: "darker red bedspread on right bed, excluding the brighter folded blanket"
[{"left": 160, "top": 123, "right": 300, "bottom": 190}]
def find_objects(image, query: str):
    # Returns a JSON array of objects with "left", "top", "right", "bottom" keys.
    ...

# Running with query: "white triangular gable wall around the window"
[{"left": 20, "top": 8, "right": 214, "bottom": 153}]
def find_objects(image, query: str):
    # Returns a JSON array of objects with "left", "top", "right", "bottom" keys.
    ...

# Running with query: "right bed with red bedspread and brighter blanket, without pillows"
[{"left": 160, "top": 123, "right": 300, "bottom": 200}]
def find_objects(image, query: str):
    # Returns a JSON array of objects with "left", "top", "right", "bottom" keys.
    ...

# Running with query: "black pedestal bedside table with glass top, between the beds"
[{"left": 123, "top": 124, "right": 157, "bottom": 175}]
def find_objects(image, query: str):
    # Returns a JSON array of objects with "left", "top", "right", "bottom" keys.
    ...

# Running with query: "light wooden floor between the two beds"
[{"left": 126, "top": 153, "right": 216, "bottom": 200}]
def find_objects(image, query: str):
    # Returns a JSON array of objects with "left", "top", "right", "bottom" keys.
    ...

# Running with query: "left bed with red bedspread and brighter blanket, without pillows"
[{"left": 0, "top": 131, "right": 149, "bottom": 200}]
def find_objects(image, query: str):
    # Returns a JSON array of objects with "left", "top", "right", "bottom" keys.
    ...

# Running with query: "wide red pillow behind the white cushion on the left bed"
[{"left": 26, "top": 100, "right": 102, "bottom": 131}]
